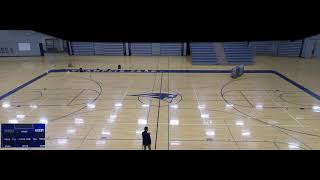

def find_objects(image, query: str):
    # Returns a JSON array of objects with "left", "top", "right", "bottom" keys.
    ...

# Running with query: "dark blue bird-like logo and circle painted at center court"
[{"left": 129, "top": 91, "right": 182, "bottom": 105}]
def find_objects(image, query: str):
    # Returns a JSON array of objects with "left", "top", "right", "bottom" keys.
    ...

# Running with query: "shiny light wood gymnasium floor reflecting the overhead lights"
[{"left": 0, "top": 56, "right": 320, "bottom": 150}]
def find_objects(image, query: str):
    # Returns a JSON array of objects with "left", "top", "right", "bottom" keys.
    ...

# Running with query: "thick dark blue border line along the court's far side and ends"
[{"left": 0, "top": 69, "right": 320, "bottom": 101}]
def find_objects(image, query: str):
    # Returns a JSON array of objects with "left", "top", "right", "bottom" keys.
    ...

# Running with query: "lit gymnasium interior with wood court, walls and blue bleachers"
[{"left": 0, "top": 30, "right": 320, "bottom": 150}]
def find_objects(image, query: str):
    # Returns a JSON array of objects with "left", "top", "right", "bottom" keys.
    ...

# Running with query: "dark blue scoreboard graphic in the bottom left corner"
[{"left": 1, "top": 124, "right": 45, "bottom": 148}]
